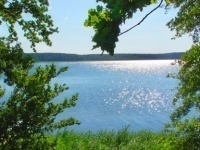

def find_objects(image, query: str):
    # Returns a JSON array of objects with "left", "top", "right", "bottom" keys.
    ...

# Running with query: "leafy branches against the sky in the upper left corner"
[{"left": 0, "top": 0, "right": 58, "bottom": 51}]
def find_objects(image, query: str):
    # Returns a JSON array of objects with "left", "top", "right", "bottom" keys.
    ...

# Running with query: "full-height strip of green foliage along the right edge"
[{"left": 166, "top": 0, "right": 200, "bottom": 149}]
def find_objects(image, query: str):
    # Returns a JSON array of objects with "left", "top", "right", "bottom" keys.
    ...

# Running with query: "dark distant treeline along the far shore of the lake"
[{"left": 25, "top": 52, "right": 184, "bottom": 61}]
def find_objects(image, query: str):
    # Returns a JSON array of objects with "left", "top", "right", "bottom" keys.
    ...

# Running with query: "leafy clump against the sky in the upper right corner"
[{"left": 167, "top": 0, "right": 200, "bottom": 43}]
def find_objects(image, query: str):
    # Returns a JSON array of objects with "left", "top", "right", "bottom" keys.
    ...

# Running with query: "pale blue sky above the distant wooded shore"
[{"left": 23, "top": 0, "right": 192, "bottom": 54}]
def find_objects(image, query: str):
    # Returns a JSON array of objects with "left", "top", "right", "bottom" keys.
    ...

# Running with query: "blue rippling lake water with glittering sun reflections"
[{"left": 0, "top": 60, "right": 179, "bottom": 131}]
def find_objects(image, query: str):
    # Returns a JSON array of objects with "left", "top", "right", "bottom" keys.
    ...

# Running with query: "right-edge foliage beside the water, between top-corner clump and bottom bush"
[{"left": 171, "top": 43, "right": 200, "bottom": 121}]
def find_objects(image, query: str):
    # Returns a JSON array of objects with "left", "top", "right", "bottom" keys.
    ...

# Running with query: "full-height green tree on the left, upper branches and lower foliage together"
[{"left": 0, "top": 0, "right": 79, "bottom": 149}]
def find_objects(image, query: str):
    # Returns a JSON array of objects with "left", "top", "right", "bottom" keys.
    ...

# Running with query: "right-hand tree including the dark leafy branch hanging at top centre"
[{"left": 85, "top": 0, "right": 200, "bottom": 149}]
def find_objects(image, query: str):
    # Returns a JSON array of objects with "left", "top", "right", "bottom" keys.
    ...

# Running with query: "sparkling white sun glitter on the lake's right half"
[{"left": 97, "top": 60, "right": 177, "bottom": 113}]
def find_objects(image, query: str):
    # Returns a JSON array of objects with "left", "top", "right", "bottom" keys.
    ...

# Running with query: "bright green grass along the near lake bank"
[{"left": 52, "top": 128, "right": 189, "bottom": 150}]
